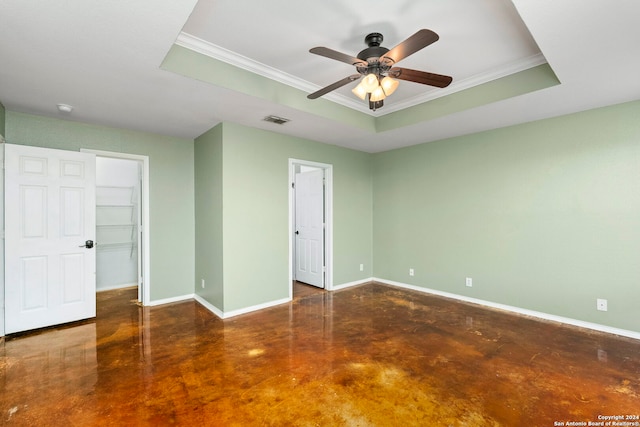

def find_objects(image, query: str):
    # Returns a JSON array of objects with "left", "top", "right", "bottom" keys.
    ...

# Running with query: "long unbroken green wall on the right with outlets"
[{"left": 373, "top": 102, "right": 640, "bottom": 331}]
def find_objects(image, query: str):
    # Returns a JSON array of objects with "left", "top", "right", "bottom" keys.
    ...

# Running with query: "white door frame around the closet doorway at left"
[{"left": 80, "top": 148, "right": 151, "bottom": 305}]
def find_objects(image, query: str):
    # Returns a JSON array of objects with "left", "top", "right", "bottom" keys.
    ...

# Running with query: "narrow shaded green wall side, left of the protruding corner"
[{"left": 195, "top": 124, "right": 224, "bottom": 311}]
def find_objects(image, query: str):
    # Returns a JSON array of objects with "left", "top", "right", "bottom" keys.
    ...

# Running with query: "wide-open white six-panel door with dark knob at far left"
[{"left": 5, "top": 144, "right": 96, "bottom": 333}]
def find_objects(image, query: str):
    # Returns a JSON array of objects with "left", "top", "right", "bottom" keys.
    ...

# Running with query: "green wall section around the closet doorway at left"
[{"left": 6, "top": 111, "right": 195, "bottom": 301}]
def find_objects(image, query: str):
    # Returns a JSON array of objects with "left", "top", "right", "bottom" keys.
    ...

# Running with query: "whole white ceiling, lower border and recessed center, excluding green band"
[{"left": 0, "top": 0, "right": 640, "bottom": 152}]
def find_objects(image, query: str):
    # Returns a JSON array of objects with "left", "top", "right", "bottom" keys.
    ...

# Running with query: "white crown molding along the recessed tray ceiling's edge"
[{"left": 176, "top": 32, "right": 547, "bottom": 117}]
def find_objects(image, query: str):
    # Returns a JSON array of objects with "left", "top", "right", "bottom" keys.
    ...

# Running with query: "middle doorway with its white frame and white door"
[{"left": 289, "top": 159, "right": 333, "bottom": 298}]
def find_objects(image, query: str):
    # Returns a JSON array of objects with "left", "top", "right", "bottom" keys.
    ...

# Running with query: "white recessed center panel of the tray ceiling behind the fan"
[{"left": 183, "top": 0, "right": 544, "bottom": 113}]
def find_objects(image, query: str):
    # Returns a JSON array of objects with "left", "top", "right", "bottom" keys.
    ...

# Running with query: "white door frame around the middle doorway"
[{"left": 289, "top": 158, "right": 333, "bottom": 299}]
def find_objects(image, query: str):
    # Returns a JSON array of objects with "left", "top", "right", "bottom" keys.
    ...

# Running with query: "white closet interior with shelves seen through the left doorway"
[{"left": 96, "top": 156, "right": 140, "bottom": 290}]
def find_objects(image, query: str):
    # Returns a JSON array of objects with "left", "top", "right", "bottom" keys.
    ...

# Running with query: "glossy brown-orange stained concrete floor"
[{"left": 0, "top": 284, "right": 640, "bottom": 426}]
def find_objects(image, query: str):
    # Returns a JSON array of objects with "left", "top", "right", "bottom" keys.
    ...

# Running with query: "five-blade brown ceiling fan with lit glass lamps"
[{"left": 307, "top": 29, "right": 453, "bottom": 111}]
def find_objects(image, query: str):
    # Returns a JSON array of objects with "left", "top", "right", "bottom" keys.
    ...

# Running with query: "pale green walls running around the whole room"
[{"left": 0, "top": 102, "right": 640, "bottom": 331}]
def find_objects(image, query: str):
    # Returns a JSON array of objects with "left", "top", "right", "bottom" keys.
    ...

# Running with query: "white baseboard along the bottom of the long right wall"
[{"left": 373, "top": 277, "right": 640, "bottom": 340}]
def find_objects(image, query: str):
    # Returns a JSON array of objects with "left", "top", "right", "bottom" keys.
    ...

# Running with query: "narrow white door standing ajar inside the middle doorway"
[{"left": 295, "top": 169, "right": 324, "bottom": 288}]
